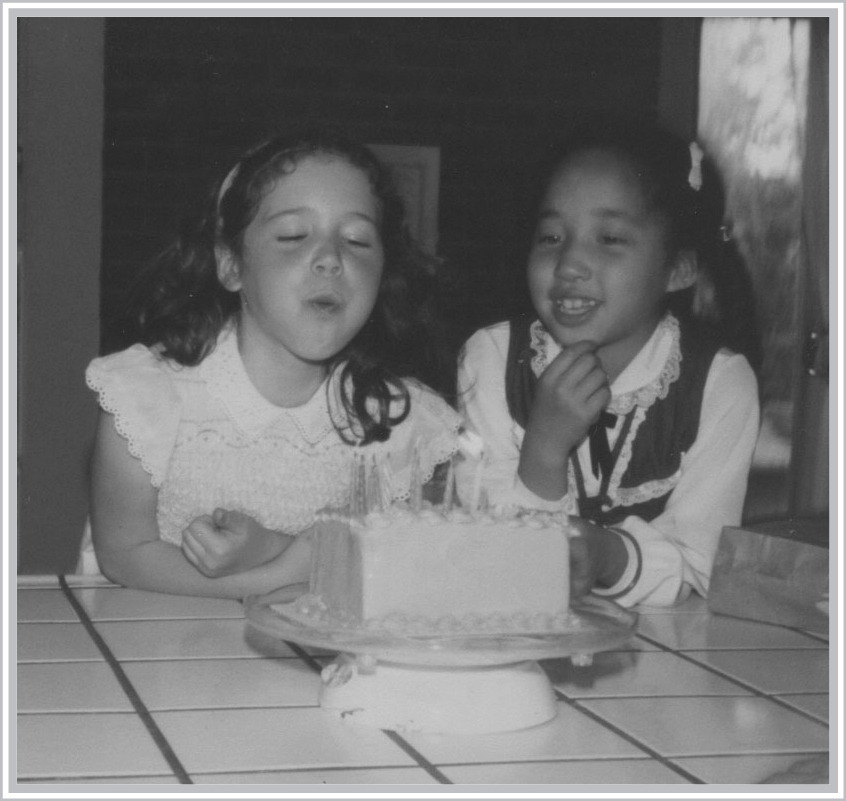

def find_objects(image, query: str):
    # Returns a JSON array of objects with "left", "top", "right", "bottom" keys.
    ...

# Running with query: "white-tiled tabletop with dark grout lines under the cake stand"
[{"left": 11, "top": 577, "right": 833, "bottom": 792}]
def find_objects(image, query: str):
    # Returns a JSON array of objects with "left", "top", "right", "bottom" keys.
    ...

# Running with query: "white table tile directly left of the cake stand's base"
[{"left": 124, "top": 659, "right": 320, "bottom": 710}]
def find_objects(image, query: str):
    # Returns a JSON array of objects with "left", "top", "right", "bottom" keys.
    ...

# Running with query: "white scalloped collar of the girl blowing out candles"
[{"left": 200, "top": 324, "right": 338, "bottom": 445}]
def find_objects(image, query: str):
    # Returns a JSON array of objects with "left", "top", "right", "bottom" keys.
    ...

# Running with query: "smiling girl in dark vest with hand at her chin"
[{"left": 458, "top": 119, "right": 759, "bottom": 606}]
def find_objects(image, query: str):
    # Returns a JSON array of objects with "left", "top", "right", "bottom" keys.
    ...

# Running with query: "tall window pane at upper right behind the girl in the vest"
[{"left": 699, "top": 17, "right": 827, "bottom": 519}]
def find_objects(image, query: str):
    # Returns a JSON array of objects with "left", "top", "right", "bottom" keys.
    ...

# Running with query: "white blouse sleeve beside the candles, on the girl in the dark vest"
[{"left": 455, "top": 323, "right": 575, "bottom": 514}]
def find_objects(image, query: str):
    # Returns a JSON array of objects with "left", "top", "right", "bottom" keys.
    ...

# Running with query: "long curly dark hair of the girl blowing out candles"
[{"left": 125, "top": 131, "right": 449, "bottom": 444}]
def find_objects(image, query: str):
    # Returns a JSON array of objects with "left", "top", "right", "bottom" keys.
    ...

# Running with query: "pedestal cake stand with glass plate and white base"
[{"left": 245, "top": 588, "right": 637, "bottom": 734}]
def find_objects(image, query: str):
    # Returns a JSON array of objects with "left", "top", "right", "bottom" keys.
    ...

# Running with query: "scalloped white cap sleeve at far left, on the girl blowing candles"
[{"left": 85, "top": 345, "right": 181, "bottom": 487}]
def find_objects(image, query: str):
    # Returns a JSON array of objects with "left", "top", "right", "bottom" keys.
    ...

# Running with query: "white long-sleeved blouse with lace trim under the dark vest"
[{"left": 457, "top": 315, "right": 759, "bottom": 606}]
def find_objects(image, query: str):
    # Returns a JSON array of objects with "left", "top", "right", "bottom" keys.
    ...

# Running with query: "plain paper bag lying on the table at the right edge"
[{"left": 708, "top": 527, "right": 829, "bottom": 633}]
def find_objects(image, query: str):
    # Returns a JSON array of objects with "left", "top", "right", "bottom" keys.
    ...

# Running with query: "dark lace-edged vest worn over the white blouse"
[{"left": 505, "top": 318, "right": 720, "bottom": 526}]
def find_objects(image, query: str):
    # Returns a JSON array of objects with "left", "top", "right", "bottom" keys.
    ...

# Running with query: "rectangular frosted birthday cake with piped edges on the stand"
[{"left": 294, "top": 507, "right": 572, "bottom": 635}]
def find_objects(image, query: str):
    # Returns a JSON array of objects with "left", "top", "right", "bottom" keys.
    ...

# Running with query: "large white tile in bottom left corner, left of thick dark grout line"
[{"left": 17, "top": 713, "right": 172, "bottom": 778}]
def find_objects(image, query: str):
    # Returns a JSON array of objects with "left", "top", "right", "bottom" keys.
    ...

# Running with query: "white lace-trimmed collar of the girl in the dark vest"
[{"left": 529, "top": 312, "right": 681, "bottom": 414}]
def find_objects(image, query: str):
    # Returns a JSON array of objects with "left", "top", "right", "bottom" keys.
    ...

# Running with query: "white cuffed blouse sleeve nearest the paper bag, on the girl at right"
[{"left": 609, "top": 351, "right": 759, "bottom": 606}]
